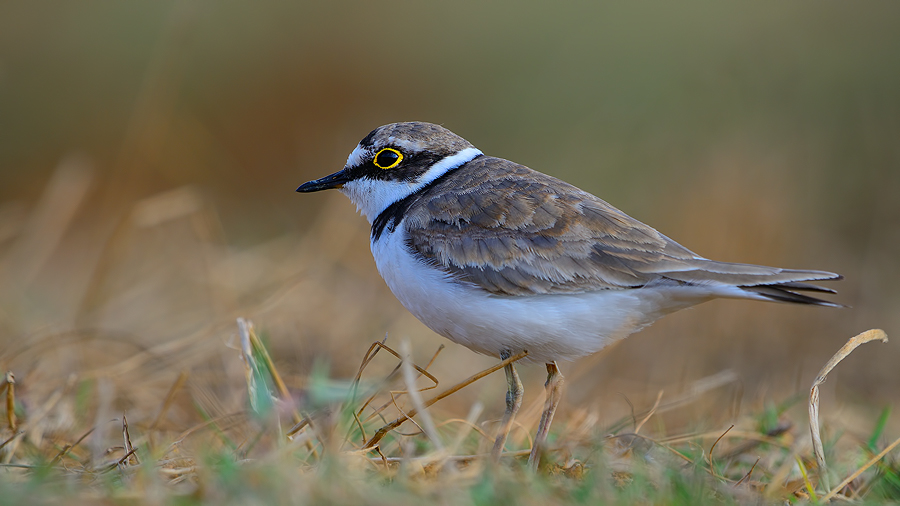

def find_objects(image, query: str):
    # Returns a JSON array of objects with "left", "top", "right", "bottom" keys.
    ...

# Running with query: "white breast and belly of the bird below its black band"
[{"left": 372, "top": 223, "right": 711, "bottom": 362}]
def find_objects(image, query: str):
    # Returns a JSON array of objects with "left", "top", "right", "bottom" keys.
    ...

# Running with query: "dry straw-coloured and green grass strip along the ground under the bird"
[{"left": 0, "top": 304, "right": 900, "bottom": 504}]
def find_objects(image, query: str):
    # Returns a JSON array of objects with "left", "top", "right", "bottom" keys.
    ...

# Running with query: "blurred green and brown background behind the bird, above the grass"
[{"left": 0, "top": 0, "right": 900, "bottom": 422}]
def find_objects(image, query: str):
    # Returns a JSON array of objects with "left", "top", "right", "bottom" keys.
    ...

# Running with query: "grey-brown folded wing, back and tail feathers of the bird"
[{"left": 405, "top": 156, "right": 837, "bottom": 302}]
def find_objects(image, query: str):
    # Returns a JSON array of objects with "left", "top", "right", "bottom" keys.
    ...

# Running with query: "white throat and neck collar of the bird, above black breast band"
[{"left": 340, "top": 148, "right": 483, "bottom": 223}]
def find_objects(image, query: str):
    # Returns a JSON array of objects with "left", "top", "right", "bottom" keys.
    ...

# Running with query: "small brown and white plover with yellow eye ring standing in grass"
[{"left": 297, "top": 122, "right": 842, "bottom": 469}]
